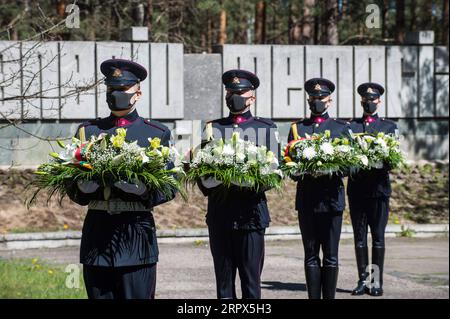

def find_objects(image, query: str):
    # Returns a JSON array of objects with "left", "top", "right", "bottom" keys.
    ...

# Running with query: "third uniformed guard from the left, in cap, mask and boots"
[{"left": 288, "top": 78, "right": 351, "bottom": 299}]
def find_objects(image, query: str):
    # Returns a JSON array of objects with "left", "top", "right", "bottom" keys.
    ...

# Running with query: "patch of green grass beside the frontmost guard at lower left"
[{"left": 0, "top": 258, "right": 87, "bottom": 299}]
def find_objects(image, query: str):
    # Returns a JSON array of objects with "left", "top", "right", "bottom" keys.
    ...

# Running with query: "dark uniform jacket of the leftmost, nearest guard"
[{"left": 68, "top": 111, "right": 175, "bottom": 267}]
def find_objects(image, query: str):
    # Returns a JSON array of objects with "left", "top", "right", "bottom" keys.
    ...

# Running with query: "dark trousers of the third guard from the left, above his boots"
[{"left": 298, "top": 211, "right": 342, "bottom": 267}]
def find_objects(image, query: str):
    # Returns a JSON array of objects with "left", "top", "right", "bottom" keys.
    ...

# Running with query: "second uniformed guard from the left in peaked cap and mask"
[{"left": 199, "top": 70, "right": 280, "bottom": 298}]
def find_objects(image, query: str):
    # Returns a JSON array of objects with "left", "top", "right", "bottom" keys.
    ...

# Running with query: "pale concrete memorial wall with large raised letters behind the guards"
[{"left": 0, "top": 32, "right": 449, "bottom": 166}]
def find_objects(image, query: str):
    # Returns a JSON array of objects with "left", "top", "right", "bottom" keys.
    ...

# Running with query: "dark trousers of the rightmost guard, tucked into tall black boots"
[{"left": 349, "top": 196, "right": 389, "bottom": 248}]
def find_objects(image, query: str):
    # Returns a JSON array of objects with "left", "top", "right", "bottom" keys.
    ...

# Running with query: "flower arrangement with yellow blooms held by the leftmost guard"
[{"left": 26, "top": 129, "right": 186, "bottom": 207}]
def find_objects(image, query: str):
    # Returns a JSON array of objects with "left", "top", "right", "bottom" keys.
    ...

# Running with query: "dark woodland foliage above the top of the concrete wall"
[{"left": 0, "top": 0, "right": 448, "bottom": 53}]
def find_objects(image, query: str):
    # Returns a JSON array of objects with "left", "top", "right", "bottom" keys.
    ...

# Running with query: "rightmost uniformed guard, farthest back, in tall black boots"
[{"left": 347, "top": 83, "right": 398, "bottom": 296}]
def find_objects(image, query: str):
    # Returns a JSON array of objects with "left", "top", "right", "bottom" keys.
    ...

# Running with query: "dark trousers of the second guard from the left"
[{"left": 208, "top": 225, "right": 265, "bottom": 299}]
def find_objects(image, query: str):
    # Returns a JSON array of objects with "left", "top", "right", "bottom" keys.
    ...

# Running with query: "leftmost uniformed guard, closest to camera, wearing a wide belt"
[{"left": 67, "top": 59, "right": 175, "bottom": 299}]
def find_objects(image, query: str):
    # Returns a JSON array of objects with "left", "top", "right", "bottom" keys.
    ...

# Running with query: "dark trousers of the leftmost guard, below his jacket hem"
[{"left": 83, "top": 263, "right": 156, "bottom": 299}]
